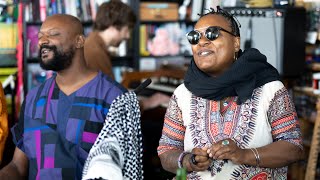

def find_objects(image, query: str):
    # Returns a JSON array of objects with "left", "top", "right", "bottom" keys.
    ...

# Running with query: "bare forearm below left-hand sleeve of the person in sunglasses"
[{"left": 159, "top": 150, "right": 182, "bottom": 174}]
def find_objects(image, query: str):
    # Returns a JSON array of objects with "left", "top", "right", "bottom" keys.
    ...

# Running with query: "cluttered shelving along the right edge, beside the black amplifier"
[{"left": 290, "top": 1, "right": 320, "bottom": 180}]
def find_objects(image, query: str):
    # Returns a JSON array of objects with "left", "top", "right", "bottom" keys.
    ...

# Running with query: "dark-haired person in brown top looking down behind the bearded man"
[{"left": 84, "top": 0, "right": 170, "bottom": 110}]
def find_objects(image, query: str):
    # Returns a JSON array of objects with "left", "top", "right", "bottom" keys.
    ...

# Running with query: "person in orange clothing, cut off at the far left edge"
[{"left": 0, "top": 82, "right": 9, "bottom": 164}]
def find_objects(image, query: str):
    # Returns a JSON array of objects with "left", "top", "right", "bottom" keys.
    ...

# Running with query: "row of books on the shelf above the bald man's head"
[{"left": 24, "top": 0, "right": 127, "bottom": 22}]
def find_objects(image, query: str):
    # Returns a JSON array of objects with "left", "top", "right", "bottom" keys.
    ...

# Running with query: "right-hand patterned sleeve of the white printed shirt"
[{"left": 267, "top": 87, "right": 303, "bottom": 149}]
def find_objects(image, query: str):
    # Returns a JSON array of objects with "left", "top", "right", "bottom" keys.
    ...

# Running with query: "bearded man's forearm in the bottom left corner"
[{"left": 0, "top": 162, "right": 26, "bottom": 180}]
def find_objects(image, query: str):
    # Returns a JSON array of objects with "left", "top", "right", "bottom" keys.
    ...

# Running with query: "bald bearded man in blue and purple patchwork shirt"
[{"left": 0, "top": 14, "right": 127, "bottom": 180}]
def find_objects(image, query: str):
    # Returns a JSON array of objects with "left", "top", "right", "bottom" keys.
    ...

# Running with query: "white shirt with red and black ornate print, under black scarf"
[{"left": 158, "top": 81, "right": 302, "bottom": 180}]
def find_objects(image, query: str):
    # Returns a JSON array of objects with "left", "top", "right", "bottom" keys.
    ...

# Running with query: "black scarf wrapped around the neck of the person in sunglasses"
[{"left": 184, "top": 48, "right": 280, "bottom": 104}]
